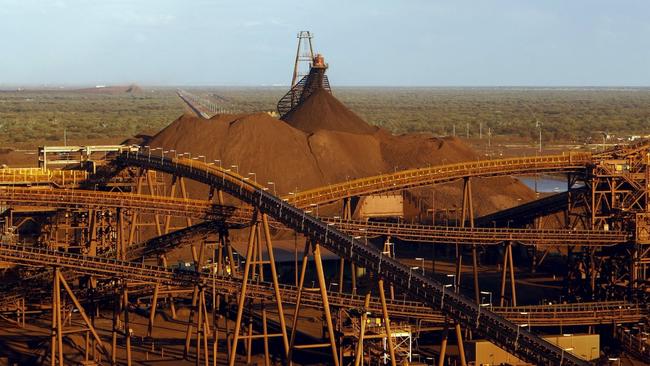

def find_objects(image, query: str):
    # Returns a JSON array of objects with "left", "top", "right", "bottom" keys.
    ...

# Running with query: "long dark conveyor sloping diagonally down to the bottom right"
[{"left": 111, "top": 152, "right": 590, "bottom": 366}]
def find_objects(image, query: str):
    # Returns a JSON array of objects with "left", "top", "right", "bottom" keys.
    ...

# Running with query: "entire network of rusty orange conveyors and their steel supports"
[{"left": 0, "top": 145, "right": 650, "bottom": 364}]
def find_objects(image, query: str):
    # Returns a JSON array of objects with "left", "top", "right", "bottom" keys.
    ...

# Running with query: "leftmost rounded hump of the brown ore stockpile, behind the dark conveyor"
[{"left": 150, "top": 113, "right": 323, "bottom": 193}]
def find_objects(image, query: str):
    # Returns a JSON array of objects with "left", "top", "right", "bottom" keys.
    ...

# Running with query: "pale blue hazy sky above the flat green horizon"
[{"left": 0, "top": 0, "right": 650, "bottom": 86}]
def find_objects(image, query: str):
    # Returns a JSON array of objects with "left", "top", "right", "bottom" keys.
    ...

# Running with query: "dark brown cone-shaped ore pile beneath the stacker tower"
[{"left": 284, "top": 89, "right": 377, "bottom": 134}]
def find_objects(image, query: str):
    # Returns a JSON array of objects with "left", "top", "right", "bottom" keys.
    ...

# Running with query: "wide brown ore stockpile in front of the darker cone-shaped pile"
[{"left": 149, "top": 113, "right": 534, "bottom": 215}]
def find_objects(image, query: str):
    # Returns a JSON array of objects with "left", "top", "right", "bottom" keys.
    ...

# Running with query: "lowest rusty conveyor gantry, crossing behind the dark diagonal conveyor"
[{"left": 0, "top": 243, "right": 648, "bottom": 326}]
